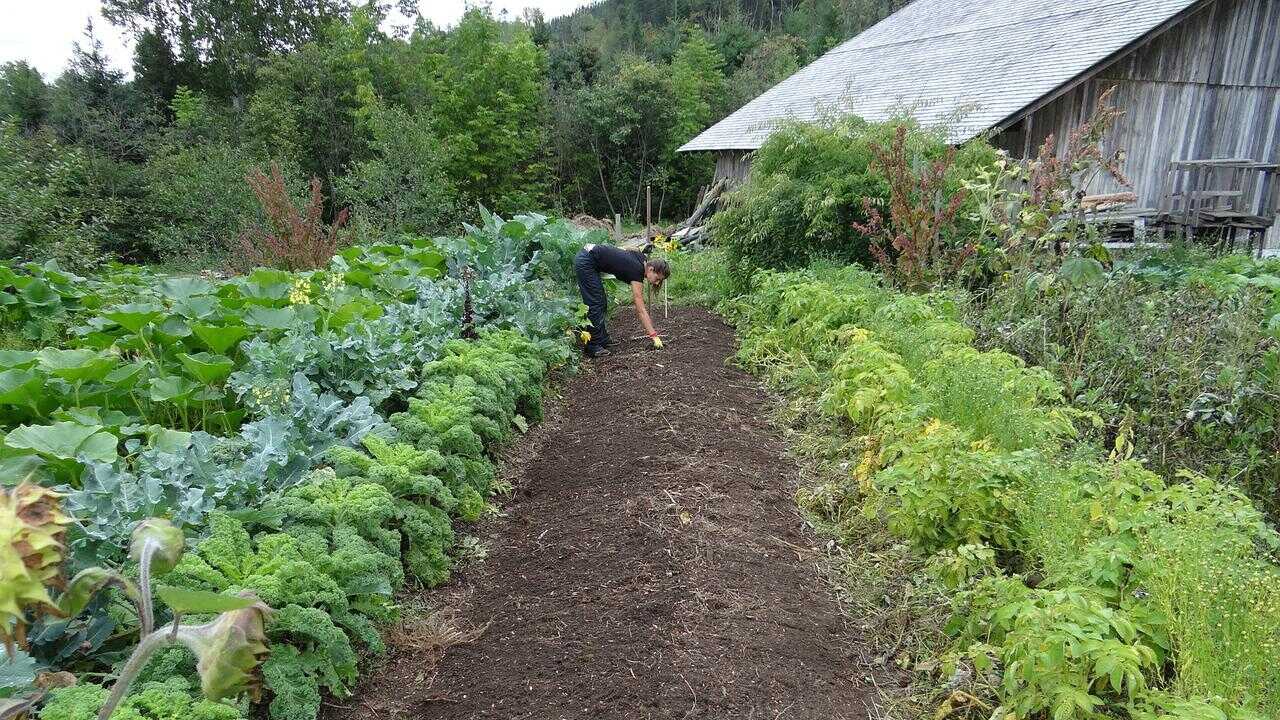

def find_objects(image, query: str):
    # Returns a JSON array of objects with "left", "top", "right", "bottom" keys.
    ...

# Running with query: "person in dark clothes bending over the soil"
[{"left": 573, "top": 245, "right": 671, "bottom": 357}]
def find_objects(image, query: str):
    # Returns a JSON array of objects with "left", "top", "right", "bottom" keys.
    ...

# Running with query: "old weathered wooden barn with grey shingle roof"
[{"left": 681, "top": 0, "right": 1280, "bottom": 249}]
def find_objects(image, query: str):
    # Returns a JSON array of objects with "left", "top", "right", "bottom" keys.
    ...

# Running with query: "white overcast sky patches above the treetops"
[{"left": 0, "top": 0, "right": 588, "bottom": 81}]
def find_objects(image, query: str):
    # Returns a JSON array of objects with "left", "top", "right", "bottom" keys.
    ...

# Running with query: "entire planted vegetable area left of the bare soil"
[{"left": 0, "top": 207, "right": 588, "bottom": 717}]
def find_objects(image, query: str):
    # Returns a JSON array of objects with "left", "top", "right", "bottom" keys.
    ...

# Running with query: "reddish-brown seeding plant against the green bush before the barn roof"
[{"left": 854, "top": 126, "right": 974, "bottom": 290}]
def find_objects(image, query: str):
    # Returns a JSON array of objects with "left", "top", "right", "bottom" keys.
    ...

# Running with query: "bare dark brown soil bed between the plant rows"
[{"left": 329, "top": 309, "right": 868, "bottom": 720}]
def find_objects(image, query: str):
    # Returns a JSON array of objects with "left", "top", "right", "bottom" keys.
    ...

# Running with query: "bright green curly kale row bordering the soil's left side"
[{"left": 33, "top": 331, "right": 561, "bottom": 720}]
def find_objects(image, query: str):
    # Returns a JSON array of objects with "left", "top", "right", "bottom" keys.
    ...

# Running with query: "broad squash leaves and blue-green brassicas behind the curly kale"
[{"left": 0, "top": 213, "right": 590, "bottom": 560}]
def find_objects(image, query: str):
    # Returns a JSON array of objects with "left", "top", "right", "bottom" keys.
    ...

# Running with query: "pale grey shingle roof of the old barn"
[{"left": 680, "top": 0, "right": 1203, "bottom": 151}]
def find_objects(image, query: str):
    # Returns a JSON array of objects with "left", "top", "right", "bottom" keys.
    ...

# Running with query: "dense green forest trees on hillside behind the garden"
[{"left": 0, "top": 0, "right": 901, "bottom": 269}]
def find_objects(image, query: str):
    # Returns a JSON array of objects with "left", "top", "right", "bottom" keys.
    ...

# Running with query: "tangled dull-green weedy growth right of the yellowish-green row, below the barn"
[{"left": 966, "top": 260, "right": 1280, "bottom": 514}]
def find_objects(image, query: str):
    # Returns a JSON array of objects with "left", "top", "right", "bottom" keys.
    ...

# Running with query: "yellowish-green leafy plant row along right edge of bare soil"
[{"left": 731, "top": 268, "right": 1280, "bottom": 720}]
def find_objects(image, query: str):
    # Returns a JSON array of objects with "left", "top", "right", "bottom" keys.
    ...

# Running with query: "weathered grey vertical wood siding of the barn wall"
[{"left": 995, "top": 0, "right": 1280, "bottom": 247}]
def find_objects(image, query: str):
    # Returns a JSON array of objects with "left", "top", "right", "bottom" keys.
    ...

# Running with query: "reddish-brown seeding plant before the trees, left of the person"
[{"left": 232, "top": 163, "right": 347, "bottom": 270}]
